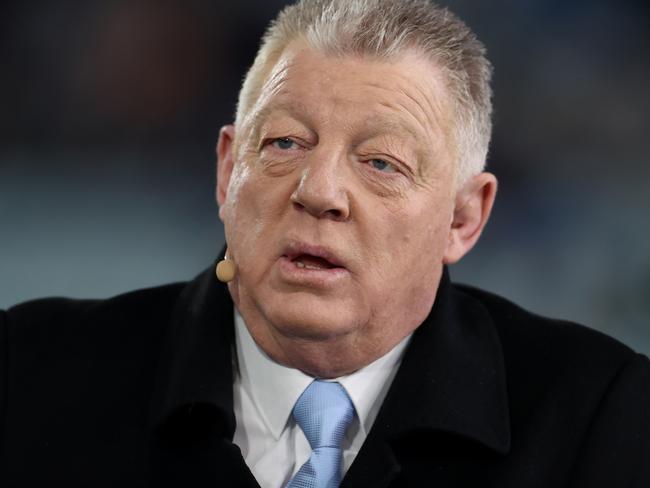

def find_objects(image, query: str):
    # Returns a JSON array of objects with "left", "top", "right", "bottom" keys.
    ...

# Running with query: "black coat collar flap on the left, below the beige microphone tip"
[{"left": 150, "top": 267, "right": 235, "bottom": 439}]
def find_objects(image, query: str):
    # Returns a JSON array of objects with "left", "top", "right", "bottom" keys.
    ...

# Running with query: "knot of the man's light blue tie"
[{"left": 293, "top": 380, "right": 354, "bottom": 449}]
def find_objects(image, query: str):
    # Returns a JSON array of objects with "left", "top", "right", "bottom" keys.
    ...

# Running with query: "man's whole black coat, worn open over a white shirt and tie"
[{"left": 0, "top": 264, "right": 650, "bottom": 488}]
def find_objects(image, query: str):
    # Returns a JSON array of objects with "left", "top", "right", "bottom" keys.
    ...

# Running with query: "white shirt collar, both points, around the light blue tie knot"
[{"left": 235, "top": 311, "right": 411, "bottom": 439}]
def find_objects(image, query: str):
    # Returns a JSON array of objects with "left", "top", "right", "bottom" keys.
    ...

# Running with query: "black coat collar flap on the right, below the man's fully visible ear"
[{"left": 372, "top": 270, "right": 510, "bottom": 453}]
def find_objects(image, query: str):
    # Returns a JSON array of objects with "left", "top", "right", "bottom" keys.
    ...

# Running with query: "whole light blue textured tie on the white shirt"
[{"left": 286, "top": 380, "right": 354, "bottom": 488}]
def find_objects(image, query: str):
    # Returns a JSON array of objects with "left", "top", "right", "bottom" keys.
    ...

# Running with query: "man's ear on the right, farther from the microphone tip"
[{"left": 443, "top": 173, "right": 497, "bottom": 264}]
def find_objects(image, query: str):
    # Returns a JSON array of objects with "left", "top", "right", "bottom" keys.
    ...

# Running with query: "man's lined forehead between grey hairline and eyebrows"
[{"left": 247, "top": 42, "right": 451, "bottom": 151}]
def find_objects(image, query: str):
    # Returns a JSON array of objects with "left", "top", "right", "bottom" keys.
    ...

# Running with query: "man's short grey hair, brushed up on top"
[{"left": 235, "top": 0, "right": 492, "bottom": 183}]
